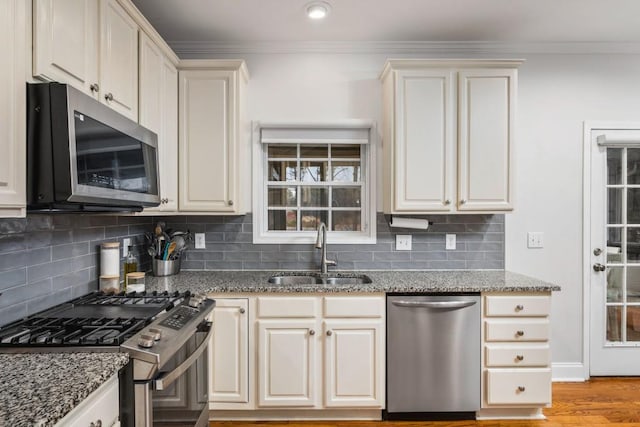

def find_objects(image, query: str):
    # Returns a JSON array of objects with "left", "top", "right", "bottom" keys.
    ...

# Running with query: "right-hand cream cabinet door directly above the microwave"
[{"left": 100, "top": 0, "right": 138, "bottom": 122}]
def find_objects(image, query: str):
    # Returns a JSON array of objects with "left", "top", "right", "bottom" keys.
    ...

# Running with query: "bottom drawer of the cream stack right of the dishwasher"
[{"left": 487, "top": 369, "right": 551, "bottom": 405}]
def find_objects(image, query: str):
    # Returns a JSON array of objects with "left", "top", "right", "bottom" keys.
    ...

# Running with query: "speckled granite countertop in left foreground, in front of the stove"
[{"left": 0, "top": 353, "right": 129, "bottom": 427}]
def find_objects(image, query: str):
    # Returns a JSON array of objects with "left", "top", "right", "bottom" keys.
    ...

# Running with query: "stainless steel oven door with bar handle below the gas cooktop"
[{"left": 151, "top": 322, "right": 213, "bottom": 427}]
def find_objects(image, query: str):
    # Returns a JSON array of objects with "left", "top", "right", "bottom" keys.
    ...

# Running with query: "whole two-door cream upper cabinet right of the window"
[{"left": 381, "top": 60, "right": 521, "bottom": 213}]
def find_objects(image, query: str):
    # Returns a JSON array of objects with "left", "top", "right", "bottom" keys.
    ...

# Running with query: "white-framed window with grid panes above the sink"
[{"left": 254, "top": 122, "right": 375, "bottom": 243}]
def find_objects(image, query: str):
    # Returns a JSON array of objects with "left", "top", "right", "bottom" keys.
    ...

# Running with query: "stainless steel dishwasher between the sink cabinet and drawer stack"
[{"left": 384, "top": 294, "right": 480, "bottom": 419}]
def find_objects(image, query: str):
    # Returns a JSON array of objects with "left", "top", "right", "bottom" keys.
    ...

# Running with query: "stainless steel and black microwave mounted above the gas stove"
[{"left": 27, "top": 83, "right": 160, "bottom": 211}]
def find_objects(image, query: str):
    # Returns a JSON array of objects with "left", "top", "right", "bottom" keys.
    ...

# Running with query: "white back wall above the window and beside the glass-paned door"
[{"left": 185, "top": 50, "right": 640, "bottom": 377}]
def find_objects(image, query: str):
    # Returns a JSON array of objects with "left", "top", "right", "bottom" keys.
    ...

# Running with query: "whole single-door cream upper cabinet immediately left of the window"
[{"left": 178, "top": 60, "right": 250, "bottom": 214}]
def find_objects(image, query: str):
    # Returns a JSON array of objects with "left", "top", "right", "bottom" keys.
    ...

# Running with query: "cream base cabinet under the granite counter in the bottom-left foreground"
[{"left": 54, "top": 374, "right": 120, "bottom": 427}]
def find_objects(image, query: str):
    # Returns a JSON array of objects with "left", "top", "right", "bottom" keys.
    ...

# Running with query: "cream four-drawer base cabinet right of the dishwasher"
[{"left": 479, "top": 293, "right": 551, "bottom": 418}]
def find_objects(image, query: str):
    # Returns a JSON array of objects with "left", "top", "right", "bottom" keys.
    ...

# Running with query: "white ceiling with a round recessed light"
[{"left": 133, "top": 0, "right": 640, "bottom": 48}]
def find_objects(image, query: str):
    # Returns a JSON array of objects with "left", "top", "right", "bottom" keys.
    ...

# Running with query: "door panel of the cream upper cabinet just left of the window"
[{"left": 178, "top": 70, "right": 239, "bottom": 212}]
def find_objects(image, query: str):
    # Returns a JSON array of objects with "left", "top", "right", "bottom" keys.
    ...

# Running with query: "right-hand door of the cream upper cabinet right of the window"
[{"left": 458, "top": 69, "right": 517, "bottom": 211}]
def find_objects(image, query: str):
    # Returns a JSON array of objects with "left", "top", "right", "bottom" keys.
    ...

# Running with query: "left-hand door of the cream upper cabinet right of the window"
[{"left": 393, "top": 69, "right": 456, "bottom": 212}]
